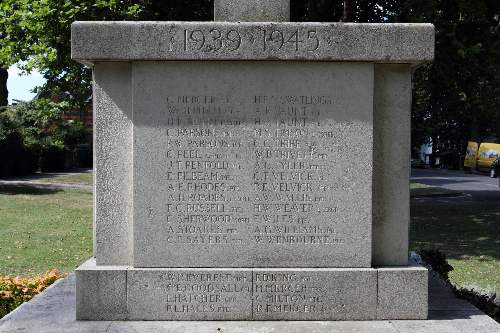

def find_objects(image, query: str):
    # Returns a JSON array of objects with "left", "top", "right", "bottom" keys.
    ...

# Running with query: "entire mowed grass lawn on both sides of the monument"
[{"left": 0, "top": 173, "right": 500, "bottom": 291}]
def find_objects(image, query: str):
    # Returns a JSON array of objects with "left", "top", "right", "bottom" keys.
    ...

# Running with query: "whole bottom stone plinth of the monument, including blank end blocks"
[{"left": 76, "top": 259, "right": 428, "bottom": 320}]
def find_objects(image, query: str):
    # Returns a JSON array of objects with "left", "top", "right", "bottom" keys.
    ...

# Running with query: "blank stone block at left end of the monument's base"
[{"left": 75, "top": 259, "right": 127, "bottom": 320}]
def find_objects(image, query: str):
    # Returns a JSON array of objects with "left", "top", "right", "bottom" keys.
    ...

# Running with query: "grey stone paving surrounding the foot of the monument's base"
[{"left": 0, "top": 274, "right": 500, "bottom": 333}]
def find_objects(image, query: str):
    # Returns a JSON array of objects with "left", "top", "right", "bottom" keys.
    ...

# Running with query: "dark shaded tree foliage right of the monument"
[{"left": 395, "top": 0, "right": 500, "bottom": 160}]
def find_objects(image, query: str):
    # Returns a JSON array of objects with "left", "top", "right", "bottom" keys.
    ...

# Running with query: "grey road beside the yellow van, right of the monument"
[{"left": 411, "top": 169, "right": 500, "bottom": 201}]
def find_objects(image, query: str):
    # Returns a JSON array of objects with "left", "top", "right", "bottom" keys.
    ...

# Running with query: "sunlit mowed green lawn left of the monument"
[{"left": 0, "top": 187, "right": 92, "bottom": 276}]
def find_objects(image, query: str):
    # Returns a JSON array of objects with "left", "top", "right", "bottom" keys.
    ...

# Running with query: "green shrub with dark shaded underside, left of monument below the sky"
[{"left": 0, "top": 99, "right": 87, "bottom": 177}]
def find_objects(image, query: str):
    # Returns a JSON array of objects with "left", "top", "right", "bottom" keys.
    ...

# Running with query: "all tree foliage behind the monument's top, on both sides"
[{"left": 0, "top": 0, "right": 500, "bottom": 158}]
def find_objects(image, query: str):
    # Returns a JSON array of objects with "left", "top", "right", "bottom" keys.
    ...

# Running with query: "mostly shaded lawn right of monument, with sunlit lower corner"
[{"left": 410, "top": 200, "right": 500, "bottom": 292}]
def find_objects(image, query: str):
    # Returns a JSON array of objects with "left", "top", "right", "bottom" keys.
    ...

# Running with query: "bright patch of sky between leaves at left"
[{"left": 7, "top": 65, "right": 45, "bottom": 104}]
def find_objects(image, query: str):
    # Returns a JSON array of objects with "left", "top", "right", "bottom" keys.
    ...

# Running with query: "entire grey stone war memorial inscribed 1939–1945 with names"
[{"left": 72, "top": 0, "right": 434, "bottom": 320}]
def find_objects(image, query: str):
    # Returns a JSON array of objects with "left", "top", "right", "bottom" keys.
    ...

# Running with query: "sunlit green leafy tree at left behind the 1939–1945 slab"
[{"left": 0, "top": 0, "right": 212, "bottom": 108}]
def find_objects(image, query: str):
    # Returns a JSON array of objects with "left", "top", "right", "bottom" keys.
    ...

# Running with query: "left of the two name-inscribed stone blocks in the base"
[{"left": 127, "top": 269, "right": 252, "bottom": 320}]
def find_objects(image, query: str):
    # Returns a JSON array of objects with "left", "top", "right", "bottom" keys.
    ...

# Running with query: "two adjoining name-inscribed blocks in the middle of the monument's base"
[{"left": 127, "top": 268, "right": 377, "bottom": 320}]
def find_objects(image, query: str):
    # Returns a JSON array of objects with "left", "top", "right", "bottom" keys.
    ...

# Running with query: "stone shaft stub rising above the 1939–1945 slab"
[{"left": 214, "top": 0, "right": 290, "bottom": 22}]
